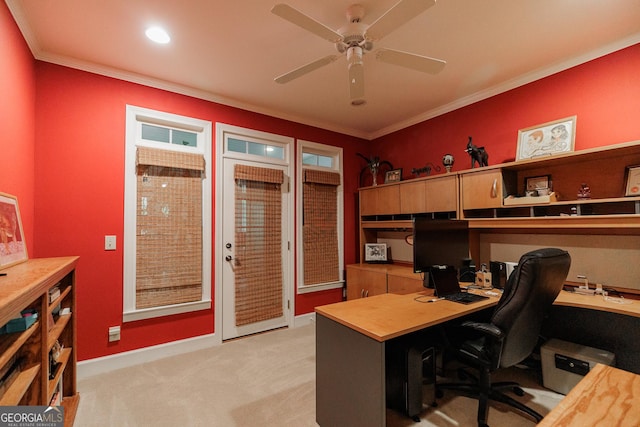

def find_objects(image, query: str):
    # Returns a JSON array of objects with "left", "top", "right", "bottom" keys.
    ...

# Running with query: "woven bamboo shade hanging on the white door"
[{"left": 234, "top": 165, "right": 284, "bottom": 326}]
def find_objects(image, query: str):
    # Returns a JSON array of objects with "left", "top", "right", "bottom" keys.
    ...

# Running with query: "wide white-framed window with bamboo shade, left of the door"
[{"left": 123, "top": 106, "right": 212, "bottom": 321}]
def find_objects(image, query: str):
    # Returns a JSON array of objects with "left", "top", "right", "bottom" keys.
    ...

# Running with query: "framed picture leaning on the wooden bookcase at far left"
[{"left": 0, "top": 193, "right": 28, "bottom": 269}]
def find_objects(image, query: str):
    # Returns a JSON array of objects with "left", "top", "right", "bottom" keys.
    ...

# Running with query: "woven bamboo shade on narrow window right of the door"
[{"left": 302, "top": 169, "right": 340, "bottom": 285}]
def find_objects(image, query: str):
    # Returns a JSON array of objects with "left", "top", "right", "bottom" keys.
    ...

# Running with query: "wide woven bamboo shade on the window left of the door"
[{"left": 136, "top": 147, "right": 204, "bottom": 308}]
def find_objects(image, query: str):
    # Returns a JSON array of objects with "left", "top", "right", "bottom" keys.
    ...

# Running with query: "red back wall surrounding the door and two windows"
[{"left": 35, "top": 62, "right": 366, "bottom": 360}]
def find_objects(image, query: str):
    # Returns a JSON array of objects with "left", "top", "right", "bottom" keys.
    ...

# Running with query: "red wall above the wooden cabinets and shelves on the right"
[{"left": 374, "top": 44, "right": 640, "bottom": 176}]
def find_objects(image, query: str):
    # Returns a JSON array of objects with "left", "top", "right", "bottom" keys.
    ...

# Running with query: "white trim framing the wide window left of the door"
[{"left": 122, "top": 105, "right": 213, "bottom": 322}]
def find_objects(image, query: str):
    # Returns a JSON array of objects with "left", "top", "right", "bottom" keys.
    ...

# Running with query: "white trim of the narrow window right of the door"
[{"left": 296, "top": 139, "right": 345, "bottom": 294}]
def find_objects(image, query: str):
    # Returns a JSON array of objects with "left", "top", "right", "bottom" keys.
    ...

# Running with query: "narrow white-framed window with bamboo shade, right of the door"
[{"left": 297, "top": 141, "right": 344, "bottom": 293}]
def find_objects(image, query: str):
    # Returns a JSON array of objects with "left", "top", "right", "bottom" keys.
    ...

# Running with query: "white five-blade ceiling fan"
[{"left": 271, "top": 0, "right": 446, "bottom": 106}]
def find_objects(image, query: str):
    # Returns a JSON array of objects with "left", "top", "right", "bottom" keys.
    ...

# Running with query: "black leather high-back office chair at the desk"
[{"left": 437, "top": 248, "right": 571, "bottom": 427}]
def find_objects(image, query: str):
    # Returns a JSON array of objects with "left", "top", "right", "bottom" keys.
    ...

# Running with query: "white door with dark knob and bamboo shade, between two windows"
[{"left": 216, "top": 158, "right": 292, "bottom": 340}]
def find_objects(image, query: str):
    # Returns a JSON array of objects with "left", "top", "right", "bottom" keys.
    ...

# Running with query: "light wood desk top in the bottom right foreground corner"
[{"left": 538, "top": 364, "right": 640, "bottom": 427}]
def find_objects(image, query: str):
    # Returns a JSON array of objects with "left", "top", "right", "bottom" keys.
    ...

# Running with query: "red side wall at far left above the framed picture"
[{"left": 0, "top": 2, "right": 36, "bottom": 254}]
